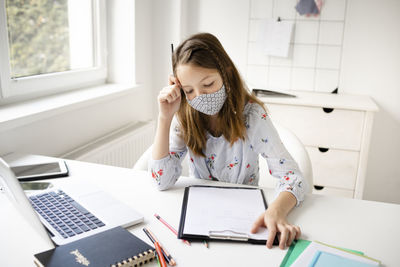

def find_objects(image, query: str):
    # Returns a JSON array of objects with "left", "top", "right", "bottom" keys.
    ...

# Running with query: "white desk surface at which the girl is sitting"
[{"left": 0, "top": 157, "right": 400, "bottom": 267}]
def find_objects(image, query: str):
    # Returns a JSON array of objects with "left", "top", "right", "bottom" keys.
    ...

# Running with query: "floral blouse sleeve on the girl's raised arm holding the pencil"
[{"left": 148, "top": 117, "right": 187, "bottom": 190}]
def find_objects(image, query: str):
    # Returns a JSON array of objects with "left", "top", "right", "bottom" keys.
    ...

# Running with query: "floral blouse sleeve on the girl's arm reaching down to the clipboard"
[{"left": 246, "top": 104, "right": 308, "bottom": 206}]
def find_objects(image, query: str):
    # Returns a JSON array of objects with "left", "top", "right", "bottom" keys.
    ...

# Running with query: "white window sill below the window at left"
[{"left": 0, "top": 84, "right": 142, "bottom": 132}]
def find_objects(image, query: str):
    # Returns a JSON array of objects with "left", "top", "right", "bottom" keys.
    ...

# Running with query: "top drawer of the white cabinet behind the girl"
[{"left": 266, "top": 104, "right": 365, "bottom": 151}]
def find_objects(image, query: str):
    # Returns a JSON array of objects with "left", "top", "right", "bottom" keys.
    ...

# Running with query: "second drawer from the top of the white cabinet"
[{"left": 306, "top": 147, "right": 359, "bottom": 190}]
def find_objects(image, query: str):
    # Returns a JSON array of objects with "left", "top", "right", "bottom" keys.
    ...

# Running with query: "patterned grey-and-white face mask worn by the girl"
[{"left": 186, "top": 85, "right": 226, "bottom": 115}]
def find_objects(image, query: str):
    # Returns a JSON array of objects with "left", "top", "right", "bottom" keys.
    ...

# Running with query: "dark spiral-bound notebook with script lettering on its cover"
[{"left": 34, "top": 227, "right": 155, "bottom": 267}]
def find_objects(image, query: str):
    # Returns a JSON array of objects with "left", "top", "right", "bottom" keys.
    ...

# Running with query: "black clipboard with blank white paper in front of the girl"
[{"left": 178, "top": 185, "right": 279, "bottom": 245}]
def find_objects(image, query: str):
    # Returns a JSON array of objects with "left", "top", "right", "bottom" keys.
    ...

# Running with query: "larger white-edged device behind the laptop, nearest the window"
[{"left": 11, "top": 160, "right": 69, "bottom": 181}]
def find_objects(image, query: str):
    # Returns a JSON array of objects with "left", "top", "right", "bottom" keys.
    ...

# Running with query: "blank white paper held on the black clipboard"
[{"left": 183, "top": 187, "right": 268, "bottom": 240}]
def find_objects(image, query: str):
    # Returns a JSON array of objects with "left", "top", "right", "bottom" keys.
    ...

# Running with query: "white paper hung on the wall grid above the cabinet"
[{"left": 258, "top": 19, "right": 293, "bottom": 57}]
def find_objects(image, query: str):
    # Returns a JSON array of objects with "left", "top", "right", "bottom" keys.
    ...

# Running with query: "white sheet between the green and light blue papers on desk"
[{"left": 291, "top": 242, "right": 379, "bottom": 267}]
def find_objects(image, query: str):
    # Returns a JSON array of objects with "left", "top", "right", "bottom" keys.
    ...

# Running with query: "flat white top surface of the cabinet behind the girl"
[{"left": 259, "top": 91, "right": 379, "bottom": 112}]
